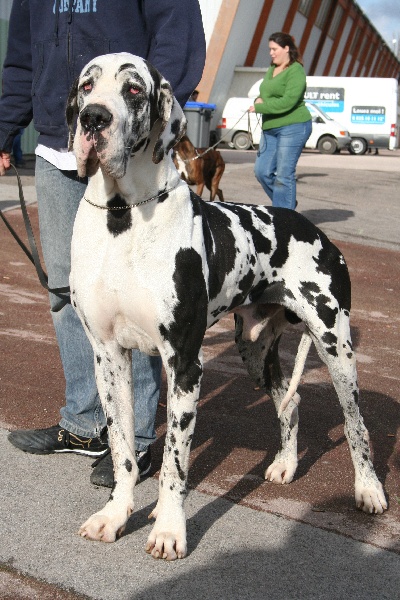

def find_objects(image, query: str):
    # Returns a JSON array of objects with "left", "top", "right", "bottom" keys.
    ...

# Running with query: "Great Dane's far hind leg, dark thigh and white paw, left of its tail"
[{"left": 235, "top": 308, "right": 299, "bottom": 483}]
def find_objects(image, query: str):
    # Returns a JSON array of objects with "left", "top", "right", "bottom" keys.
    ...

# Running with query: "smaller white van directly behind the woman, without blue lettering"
[{"left": 217, "top": 95, "right": 351, "bottom": 154}]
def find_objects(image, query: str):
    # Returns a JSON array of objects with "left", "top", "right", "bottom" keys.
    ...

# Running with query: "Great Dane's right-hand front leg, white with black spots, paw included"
[{"left": 146, "top": 356, "right": 202, "bottom": 560}]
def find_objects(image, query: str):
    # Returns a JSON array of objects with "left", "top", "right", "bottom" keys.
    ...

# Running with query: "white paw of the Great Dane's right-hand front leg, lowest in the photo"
[{"left": 145, "top": 511, "right": 187, "bottom": 560}]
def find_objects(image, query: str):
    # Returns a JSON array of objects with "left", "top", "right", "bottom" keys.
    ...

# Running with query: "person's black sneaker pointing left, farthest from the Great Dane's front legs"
[{"left": 8, "top": 425, "right": 108, "bottom": 456}]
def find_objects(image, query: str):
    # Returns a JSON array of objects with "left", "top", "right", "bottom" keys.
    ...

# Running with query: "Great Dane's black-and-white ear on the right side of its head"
[{"left": 153, "top": 79, "right": 186, "bottom": 165}]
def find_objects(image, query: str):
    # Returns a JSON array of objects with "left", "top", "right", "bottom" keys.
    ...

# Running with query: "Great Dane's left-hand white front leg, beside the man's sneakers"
[{"left": 79, "top": 342, "right": 138, "bottom": 542}]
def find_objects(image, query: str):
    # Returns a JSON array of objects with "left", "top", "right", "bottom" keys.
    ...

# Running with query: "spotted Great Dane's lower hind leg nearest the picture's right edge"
[{"left": 314, "top": 311, "right": 387, "bottom": 513}]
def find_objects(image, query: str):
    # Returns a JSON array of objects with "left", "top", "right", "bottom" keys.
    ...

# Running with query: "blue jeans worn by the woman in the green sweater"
[{"left": 254, "top": 121, "right": 312, "bottom": 210}]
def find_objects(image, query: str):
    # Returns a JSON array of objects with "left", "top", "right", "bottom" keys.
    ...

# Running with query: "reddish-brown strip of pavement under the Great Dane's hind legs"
[{"left": 0, "top": 206, "right": 400, "bottom": 552}]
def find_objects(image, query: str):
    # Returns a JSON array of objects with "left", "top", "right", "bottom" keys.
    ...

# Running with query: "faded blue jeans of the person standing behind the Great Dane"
[{"left": 35, "top": 156, "right": 161, "bottom": 450}]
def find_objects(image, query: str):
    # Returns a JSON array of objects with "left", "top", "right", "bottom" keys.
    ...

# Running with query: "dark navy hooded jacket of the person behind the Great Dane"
[{"left": 0, "top": 0, "right": 205, "bottom": 152}]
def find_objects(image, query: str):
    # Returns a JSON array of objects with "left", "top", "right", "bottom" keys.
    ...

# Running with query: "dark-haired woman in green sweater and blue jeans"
[{"left": 250, "top": 32, "right": 311, "bottom": 209}]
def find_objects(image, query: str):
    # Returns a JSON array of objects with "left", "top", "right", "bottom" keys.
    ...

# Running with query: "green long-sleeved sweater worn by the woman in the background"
[{"left": 254, "top": 62, "right": 311, "bottom": 129}]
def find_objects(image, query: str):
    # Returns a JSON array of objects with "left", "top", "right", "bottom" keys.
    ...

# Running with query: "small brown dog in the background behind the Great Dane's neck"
[{"left": 173, "top": 135, "right": 225, "bottom": 202}]
